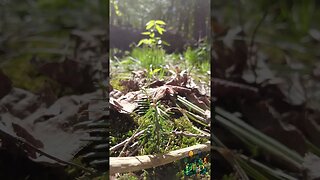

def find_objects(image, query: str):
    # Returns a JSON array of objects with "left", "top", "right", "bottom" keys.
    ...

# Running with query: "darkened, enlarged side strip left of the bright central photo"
[{"left": 0, "top": 0, "right": 108, "bottom": 180}]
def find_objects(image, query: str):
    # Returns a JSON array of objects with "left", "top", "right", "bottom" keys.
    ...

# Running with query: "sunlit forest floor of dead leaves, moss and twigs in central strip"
[{"left": 109, "top": 46, "right": 211, "bottom": 179}]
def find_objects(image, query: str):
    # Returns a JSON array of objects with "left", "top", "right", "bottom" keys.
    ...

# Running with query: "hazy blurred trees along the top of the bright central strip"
[{"left": 110, "top": 0, "right": 210, "bottom": 40}]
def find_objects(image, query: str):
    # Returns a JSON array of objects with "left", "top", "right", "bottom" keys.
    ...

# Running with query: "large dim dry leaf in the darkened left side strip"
[{"left": 0, "top": 90, "right": 104, "bottom": 164}]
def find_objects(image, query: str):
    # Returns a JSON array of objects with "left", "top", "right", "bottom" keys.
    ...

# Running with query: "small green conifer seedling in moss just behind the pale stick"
[{"left": 132, "top": 93, "right": 206, "bottom": 155}]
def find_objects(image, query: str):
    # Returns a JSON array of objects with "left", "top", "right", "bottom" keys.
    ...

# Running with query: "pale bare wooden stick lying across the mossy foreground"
[{"left": 110, "top": 141, "right": 210, "bottom": 174}]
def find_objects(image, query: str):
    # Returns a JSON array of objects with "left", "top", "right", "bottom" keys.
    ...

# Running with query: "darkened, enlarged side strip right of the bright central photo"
[{"left": 211, "top": 0, "right": 320, "bottom": 179}]
